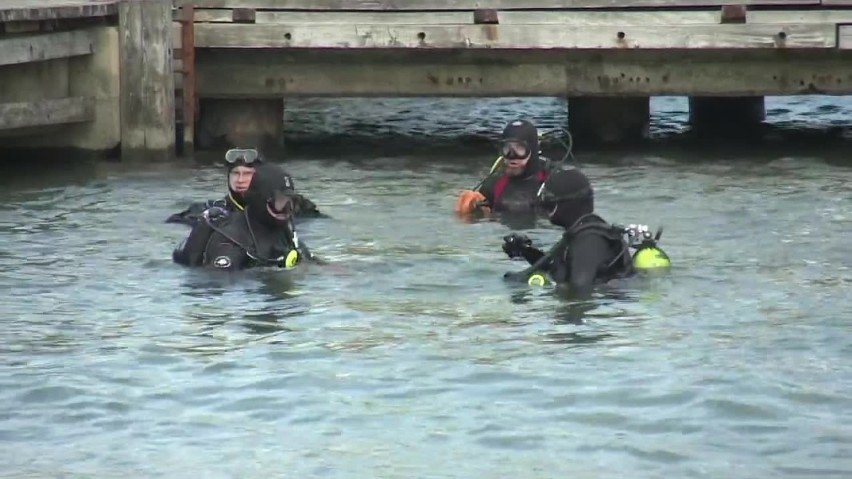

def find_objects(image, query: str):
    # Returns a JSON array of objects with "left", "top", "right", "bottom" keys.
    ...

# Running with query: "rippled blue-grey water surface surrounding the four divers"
[{"left": 5, "top": 95, "right": 852, "bottom": 479}]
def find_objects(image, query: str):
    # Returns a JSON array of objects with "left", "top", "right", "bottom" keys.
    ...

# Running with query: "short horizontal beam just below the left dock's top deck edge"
[{"left": 0, "top": 30, "right": 95, "bottom": 65}]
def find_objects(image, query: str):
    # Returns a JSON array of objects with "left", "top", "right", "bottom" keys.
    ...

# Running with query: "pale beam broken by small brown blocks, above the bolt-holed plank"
[{"left": 175, "top": 8, "right": 852, "bottom": 26}]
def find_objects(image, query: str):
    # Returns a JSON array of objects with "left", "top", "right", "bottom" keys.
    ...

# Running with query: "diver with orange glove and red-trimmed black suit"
[{"left": 455, "top": 120, "right": 571, "bottom": 215}]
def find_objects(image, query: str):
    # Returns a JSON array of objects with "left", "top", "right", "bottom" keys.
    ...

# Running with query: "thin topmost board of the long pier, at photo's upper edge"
[{"left": 175, "top": 0, "right": 820, "bottom": 11}]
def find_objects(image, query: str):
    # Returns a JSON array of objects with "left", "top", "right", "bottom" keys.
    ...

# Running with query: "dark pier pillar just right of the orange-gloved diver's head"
[{"left": 568, "top": 97, "right": 651, "bottom": 144}]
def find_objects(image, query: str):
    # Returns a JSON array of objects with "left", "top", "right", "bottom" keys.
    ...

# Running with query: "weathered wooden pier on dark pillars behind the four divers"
[{"left": 0, "top": 0, "right": 852, "bottom": 158}]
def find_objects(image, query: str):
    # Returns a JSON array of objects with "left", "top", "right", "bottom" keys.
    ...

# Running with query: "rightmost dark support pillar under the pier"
[{"left": 689, "top": 96, "right": 766, "bottom": 135}]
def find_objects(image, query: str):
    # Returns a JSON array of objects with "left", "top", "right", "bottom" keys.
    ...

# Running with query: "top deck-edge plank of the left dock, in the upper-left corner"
[{"left": 0, "top": 0, "right": 118, "bottom": 23}]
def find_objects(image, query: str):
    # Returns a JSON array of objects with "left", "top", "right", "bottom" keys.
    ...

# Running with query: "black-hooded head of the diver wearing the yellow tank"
[{"left": 538, "top": 168, "right": 595, "bottom": 229}]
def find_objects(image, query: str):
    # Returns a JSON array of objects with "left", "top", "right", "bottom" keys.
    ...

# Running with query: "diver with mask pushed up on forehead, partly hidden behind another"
[{"left": 166, "top": 148, "right": 326, "bottom": 226}]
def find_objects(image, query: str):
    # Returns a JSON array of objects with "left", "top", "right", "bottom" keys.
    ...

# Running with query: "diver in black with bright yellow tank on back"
[{"left": 503, "top": 168, "right": 670, "bottom": 297}]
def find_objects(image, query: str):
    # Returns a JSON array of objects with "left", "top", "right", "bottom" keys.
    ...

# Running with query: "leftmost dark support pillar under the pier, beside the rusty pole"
[{"left": 196, "top": 98, "right": 284, "bottom": 151}]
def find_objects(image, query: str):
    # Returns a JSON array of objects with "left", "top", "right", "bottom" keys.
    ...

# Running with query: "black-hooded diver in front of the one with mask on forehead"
[{"left": 172, "top": 164, "right": 322, "bottom": 270}]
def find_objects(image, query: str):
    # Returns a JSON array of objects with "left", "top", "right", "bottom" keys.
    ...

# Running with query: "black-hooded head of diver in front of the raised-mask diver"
[{"left": 244, "top": 163, "right": 296, "bottom": 227}]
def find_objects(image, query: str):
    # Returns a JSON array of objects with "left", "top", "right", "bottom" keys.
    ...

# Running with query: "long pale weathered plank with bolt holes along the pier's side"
[{"left": 195, "top": 23, "right": 837, "bottom": 49}]
